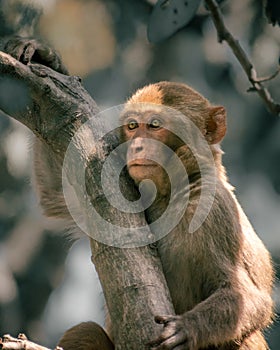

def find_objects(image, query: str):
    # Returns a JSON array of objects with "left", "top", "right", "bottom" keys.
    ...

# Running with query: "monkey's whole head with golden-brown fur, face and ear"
[{"left": 121, "top": 82, "right": 226, "bottom": 190}]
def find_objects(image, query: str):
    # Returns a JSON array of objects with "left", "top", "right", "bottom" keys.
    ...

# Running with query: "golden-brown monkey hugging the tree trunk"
[{"left": 2, "top": 39, "right": 274, "bottom": 350}]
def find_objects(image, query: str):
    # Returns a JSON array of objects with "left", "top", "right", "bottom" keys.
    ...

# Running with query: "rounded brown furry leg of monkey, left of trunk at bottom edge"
[{"left": 58, "top": 322, "right": 115, "bottom": 350}]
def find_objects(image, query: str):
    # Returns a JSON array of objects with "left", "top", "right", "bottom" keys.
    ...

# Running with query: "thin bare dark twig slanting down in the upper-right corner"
[{"left": 205, "top": 0, "right": 280, "bottom": 115}]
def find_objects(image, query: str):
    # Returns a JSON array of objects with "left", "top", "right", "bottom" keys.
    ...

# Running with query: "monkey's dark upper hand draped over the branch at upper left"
[{"left": 3, "top": 36, "right": 68, "bottom": 75}]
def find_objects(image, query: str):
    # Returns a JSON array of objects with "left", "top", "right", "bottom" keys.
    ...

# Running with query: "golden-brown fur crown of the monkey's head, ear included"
[{"left": 123, "top": 81, "right": 229, "bottom": 172}]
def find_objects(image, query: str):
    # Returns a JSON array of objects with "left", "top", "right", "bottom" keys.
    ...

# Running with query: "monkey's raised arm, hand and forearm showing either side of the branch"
[{"left": 1, "top": 36, "right": 76, "bottom": 232}]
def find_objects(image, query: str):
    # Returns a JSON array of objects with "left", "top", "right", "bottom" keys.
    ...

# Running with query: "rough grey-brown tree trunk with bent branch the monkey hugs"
[{"left": 0, "top": 52, "right": 174, "bottom": 350}]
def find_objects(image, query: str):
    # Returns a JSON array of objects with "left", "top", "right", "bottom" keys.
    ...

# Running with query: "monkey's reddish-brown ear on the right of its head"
[{"left": 205, "top": 106, "right": 227, "bottom": 144}]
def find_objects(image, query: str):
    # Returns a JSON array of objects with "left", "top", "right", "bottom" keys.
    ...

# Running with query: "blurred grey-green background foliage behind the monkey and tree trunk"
[{"left": 0, "top": 0, "right": 280, "bottom": 350}]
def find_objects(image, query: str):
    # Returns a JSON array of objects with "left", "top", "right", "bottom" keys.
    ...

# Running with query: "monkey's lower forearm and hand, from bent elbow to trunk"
[{"left": 150, "top": 288, "right": 272, "bottom": 350}]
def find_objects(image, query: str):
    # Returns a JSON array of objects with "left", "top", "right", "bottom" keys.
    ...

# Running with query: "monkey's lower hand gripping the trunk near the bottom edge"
[{"left": 148, "top": 316, "right": 197, "bottom": 350}]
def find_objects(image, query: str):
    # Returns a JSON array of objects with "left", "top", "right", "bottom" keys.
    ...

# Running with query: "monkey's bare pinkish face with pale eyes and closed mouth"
[{"left": 123, "top": 111, "right": 182, "bottom": 185}]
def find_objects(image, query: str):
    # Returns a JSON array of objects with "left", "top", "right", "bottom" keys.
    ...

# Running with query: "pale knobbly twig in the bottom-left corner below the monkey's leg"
[{"left": 0, "top": 333, "right": 63, "bottom": 350}]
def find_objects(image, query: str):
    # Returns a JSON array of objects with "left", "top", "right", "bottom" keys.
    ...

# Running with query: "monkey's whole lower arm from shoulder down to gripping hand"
[{"left": 151, "top": 189, "right": 273, "bottom": 350}]
